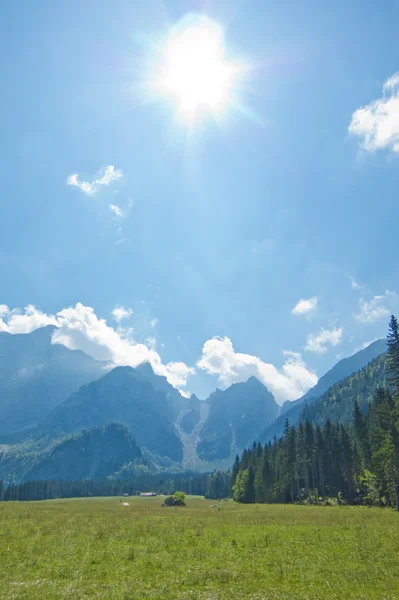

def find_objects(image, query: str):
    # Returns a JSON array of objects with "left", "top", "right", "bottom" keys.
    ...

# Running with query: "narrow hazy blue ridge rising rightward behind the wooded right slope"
[{"left": 260, "top": 340, "right": 386, "bottom": 442}]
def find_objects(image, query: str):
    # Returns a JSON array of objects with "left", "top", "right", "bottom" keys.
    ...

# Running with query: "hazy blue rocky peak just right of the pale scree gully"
[{"left": 197, "top": 377, "right": 278, "bottom": 461}]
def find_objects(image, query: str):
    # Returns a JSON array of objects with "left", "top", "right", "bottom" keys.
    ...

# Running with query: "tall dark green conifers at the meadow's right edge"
[{"left": 232, "top": 316, "right": 399, "bottom": 510}]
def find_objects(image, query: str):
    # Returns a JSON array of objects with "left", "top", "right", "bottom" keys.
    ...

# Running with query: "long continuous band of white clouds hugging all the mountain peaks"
[{"left": 0, "top": 303, "right": 317, "bottom": 402}]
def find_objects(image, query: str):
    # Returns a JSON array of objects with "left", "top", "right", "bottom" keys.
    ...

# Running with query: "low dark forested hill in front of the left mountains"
[{"left": 24, "top": 423, "right": 142, "bottom": 481}]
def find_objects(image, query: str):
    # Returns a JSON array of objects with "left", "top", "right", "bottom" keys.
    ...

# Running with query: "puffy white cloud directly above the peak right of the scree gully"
[{"left": 197, "top": 337, "right": 317, "bottom": 403}]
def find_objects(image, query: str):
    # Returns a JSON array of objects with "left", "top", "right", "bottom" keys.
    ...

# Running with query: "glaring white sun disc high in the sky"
[{"left": 155, "top": 16, "right": 237, "bottom": 120}]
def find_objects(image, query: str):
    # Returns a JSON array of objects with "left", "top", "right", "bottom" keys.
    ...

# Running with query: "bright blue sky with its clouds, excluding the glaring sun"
[{"left": 0, "top": 0, "right": 399, "bottom": 401}]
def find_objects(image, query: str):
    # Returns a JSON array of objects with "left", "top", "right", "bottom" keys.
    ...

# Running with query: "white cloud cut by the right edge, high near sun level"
[{"left": 349, "top": 72, "right": 399, "bottom": 152}]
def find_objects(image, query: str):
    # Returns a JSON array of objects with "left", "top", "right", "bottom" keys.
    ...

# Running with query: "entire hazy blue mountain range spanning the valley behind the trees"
[{"left": 0, "top": 327, "right": 386, "bottom": 480}]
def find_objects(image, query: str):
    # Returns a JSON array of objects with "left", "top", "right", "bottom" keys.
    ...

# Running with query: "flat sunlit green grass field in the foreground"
[{"left": 0, "top": 497, "right": 399, "bottom": 600}]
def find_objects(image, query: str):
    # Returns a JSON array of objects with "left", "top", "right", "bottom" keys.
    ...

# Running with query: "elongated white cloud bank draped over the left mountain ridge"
[{"left": 0, "top": 303, "right": 195, "bottom": 393}]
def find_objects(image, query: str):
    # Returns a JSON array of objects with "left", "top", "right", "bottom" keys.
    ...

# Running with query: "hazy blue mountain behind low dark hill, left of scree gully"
[{"left": 44, "top": 367, "right": 183, "bottom": 461}]
